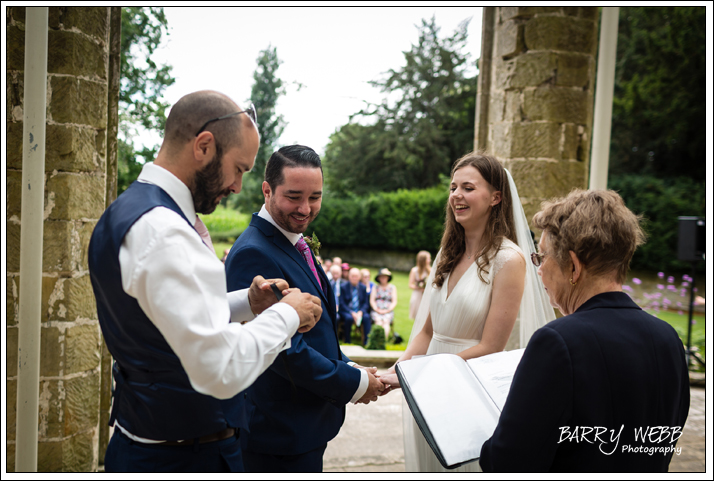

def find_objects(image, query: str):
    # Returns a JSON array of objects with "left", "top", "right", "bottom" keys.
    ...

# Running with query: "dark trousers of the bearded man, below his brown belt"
[{"left": 104, "top": 429, "right": 244, "bottom": 473}]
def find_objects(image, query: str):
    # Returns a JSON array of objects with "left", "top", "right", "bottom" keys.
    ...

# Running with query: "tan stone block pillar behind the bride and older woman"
[{"left": 475, "top": 7, "right": 598, "bottom": 232}]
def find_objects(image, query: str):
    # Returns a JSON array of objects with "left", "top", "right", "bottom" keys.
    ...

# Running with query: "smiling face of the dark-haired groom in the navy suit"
[{"left": 263, "top": 167, "right": 322, "bottom": 234}]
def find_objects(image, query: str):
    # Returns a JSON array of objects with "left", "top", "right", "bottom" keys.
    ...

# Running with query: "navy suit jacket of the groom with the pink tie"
[{"left": 226, "top": 214, "right": 361, "bottom": 455}]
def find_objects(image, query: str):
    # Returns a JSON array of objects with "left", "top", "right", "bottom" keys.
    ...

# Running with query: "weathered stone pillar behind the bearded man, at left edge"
[{"left": 6, "top": 7, "right": 116, "bottom": 471}]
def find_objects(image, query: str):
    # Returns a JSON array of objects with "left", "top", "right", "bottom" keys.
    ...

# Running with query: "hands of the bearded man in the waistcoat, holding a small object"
[{"left": 248, "top": 276, "right": 322, "bottom": 333}]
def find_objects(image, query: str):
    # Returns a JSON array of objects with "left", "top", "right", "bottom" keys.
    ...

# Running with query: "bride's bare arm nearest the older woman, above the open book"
[{"left": 458, "top": 251, "right": 526, "bottom": 359}]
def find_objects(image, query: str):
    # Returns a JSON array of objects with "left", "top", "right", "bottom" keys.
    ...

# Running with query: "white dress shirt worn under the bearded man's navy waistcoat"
[{"left": 119, "top": 163, "right": 300, "bottom": 441}]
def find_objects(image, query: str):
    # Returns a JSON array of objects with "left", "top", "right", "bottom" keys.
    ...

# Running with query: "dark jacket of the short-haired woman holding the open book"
[{"left": 480, "top": 292, "right": 689, "bottom": 472}]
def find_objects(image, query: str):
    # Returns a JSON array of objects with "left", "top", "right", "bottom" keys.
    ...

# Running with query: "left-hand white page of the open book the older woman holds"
[{"left": 399, "top": 354, "right": 500, "bottom": 465}]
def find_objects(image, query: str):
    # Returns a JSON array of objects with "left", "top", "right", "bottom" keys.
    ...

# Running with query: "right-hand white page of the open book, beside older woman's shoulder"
[{"left": 467, "top": 349, "right": 525, "bottom": 412}]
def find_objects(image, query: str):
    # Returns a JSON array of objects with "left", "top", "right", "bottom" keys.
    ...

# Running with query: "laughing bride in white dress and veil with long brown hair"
[{"left": 380, "top": 152, "right": 555, "bottom": 472}]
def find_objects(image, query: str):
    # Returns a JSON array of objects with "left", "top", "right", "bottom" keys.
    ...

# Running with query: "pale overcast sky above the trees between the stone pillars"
[{"left": 142, "top": 6, "right": 482, "bottom": 153}]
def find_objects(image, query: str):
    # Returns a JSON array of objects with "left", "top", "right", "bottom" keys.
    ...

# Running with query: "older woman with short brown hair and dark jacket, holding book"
[{"left": 475, "top": 189, "right": 689, "bottom": 472}]
